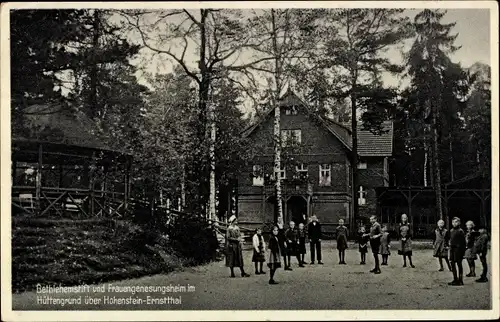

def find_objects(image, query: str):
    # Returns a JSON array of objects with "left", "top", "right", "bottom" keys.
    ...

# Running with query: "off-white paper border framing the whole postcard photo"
[{"left": 0, "top": 1, "right": 500, "bottom": 321}]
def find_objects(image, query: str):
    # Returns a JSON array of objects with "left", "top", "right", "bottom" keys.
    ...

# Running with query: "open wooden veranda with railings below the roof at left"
[{"left": 11, "top": 139, "right": 132, "bottom": 218}]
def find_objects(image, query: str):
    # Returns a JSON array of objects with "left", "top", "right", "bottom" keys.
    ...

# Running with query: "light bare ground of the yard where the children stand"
[{"left": 9, "top": 243, "right": 491, "bottom": 310}]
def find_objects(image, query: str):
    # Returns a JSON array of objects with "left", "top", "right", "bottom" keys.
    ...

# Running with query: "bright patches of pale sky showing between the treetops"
[{"left": 123, "top": 9, "right": 491, "bottom": 117}]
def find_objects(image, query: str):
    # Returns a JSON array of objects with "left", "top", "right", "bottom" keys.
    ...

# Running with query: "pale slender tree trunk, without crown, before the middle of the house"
[{"left": 271, "top": 9, "right": 284, "bottom": 228}]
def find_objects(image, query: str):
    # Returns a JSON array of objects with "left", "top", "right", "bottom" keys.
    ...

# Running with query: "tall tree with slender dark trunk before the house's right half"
[{"left": 315, "top": 9, "right": 412, "bottom": 227}]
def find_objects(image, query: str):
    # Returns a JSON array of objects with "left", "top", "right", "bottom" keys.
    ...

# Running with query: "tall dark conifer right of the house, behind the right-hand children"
[{"left": 407, "top": 9, "right": 459, "bottom": 225}]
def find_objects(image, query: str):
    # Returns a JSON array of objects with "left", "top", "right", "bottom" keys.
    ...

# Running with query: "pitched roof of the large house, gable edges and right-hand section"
[{"left": 242, "top": 89, "right": 393, "bottom": 157}]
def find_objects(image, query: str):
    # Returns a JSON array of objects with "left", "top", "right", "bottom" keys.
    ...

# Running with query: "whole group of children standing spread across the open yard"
[{"left": 228, "top": 214, "right": 489, "bottom": 286}]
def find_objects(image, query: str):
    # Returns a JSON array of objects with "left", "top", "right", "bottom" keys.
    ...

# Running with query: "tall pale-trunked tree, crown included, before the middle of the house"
[{"left": 241, "top": 9, "right": 323, "bottom": 226}]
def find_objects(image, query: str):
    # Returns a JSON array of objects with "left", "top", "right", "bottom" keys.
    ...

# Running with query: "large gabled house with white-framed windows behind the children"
[{"left": 237, "top": 91, "right": 393, "bottom": 231}]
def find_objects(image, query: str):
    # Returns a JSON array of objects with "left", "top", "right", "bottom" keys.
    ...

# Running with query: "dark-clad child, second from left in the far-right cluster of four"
[{"left": 448, "top": 217, "right": 465, "bottom": 286}]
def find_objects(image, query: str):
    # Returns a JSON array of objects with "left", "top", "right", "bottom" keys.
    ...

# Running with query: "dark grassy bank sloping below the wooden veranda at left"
[{"left": 12, "top": 218, "right": 191, "bottom": 292}]
